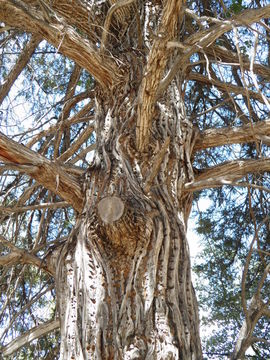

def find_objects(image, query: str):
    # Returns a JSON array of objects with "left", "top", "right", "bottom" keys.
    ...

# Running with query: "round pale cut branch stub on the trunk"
[{"left": 98, "top": 196, "right": 125, "bottom": 224}]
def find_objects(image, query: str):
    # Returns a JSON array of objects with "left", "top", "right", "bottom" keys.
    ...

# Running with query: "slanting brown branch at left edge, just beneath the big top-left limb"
[{"left": 0, "top": 36, "right": 40, "bottom": 105}]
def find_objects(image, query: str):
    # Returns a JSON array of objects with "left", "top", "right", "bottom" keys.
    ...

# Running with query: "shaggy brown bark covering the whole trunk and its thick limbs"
[{"left": 0, "top": 0, "right": 270, "bottom": 360}]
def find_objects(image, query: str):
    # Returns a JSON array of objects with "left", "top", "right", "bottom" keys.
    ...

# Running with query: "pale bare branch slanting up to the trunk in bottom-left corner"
[{"left": 1, "top": 319, "right": 60, "bottom": 356}]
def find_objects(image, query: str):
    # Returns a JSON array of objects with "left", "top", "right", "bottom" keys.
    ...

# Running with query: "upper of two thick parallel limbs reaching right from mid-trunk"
[{"left": 194, "top": 119, "right": 270, "bottom": 151}]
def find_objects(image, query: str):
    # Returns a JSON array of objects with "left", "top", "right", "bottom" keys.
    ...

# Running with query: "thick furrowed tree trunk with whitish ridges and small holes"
[{"left": 57, "top": 79, "right": 202, "bottom": 360}]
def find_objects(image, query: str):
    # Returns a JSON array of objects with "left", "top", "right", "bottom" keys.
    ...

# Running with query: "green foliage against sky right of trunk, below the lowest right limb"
[{"left": 193, "top": 183, "right": 270, "bottom": 360}]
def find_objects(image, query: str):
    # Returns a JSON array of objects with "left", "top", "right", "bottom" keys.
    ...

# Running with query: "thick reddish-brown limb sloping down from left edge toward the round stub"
[{"left": 0, "top": 133, "right": 83, "bottom": 212}]
